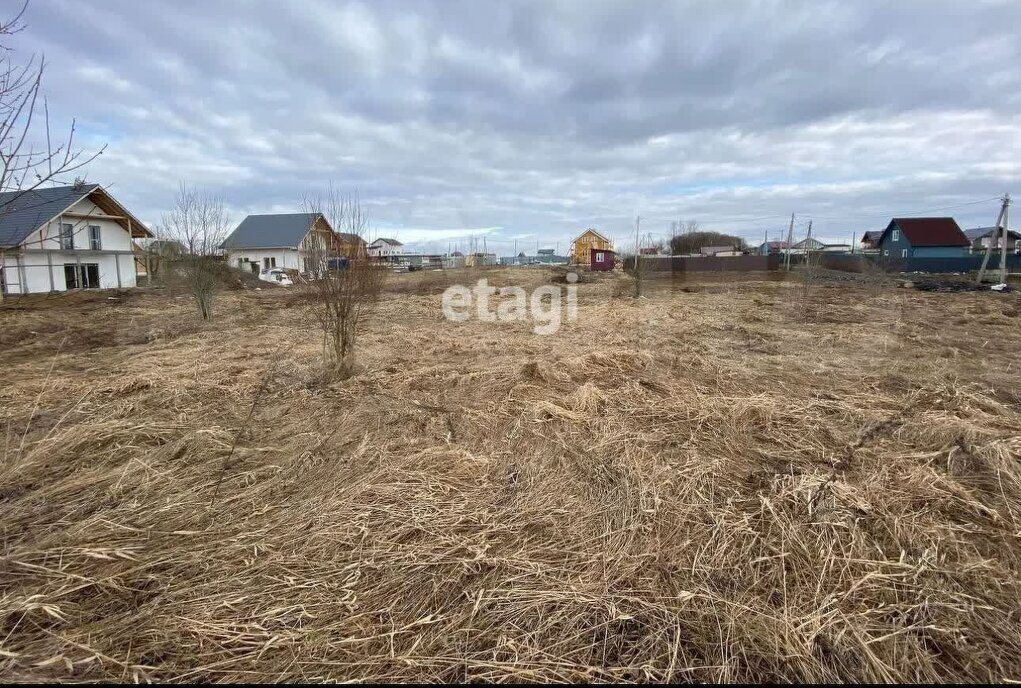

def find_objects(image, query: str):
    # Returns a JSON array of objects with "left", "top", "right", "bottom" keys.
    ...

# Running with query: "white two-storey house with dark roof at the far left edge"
[{"left": 0, "top": 184, "right": 152, "bottom": 294}]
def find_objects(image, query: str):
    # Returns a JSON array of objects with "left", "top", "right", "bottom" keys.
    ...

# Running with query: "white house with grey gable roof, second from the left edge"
[{"left": 221, "top": 212, "right": 338, "bottom": 273}]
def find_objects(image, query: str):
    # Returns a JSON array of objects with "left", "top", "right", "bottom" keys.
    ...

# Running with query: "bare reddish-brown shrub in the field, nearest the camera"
[{"left": 302, "top": 185, "right": 386, "bottom": 382}]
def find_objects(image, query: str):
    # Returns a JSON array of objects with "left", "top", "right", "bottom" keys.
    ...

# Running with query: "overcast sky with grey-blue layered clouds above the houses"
[{"left": 9, "top": 0, "right": 1021, "bottom": 254}]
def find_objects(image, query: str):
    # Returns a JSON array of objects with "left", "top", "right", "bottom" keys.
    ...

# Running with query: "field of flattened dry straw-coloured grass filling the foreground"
[{"left": 0, "top": 268, "right": 1021, "bottom": 682}]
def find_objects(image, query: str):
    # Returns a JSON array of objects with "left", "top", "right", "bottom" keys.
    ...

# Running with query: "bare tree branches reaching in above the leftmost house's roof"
[{"left": 0, "top": 0, "right": 105, "bottom": 301}]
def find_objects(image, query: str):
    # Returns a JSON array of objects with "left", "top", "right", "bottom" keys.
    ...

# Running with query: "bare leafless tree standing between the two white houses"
[{"left": 159, "top": 182, "right": 231, "bottom": 321}]
